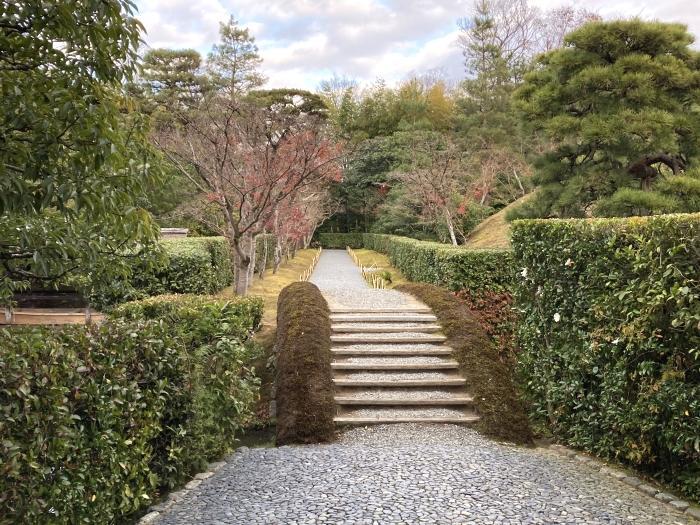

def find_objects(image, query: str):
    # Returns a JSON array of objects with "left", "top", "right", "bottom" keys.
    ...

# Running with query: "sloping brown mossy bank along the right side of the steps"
[{"left": 396, "top": 283, "right": 533, "bottom": 445}]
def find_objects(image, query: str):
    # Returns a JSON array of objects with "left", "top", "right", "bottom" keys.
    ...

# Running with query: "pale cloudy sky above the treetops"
[{"left": 136, "top": 0, "right": 700, "bottom": 89}]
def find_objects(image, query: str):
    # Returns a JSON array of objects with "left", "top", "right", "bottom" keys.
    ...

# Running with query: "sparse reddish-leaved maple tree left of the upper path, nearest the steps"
[{"left": 155, "top": 96, "right": 342, "bottom": 295}]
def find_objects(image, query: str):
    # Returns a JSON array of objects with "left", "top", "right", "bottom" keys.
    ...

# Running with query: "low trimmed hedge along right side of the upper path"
[{"left": 319, "top": 233, "right": 515, "bottom": 296}]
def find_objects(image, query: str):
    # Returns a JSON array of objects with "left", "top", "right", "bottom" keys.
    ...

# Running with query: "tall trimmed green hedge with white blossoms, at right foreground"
[{"left": 512, "top": 214, "right": 700, "bottom": 500}]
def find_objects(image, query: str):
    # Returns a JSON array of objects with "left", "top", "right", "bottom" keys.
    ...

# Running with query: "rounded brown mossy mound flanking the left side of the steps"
[{"left": 276, "top": 282, "right": 335, "bottom": 445}]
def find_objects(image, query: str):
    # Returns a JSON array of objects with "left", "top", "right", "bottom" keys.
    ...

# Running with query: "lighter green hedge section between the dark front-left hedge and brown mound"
[{"left": 111, "top": 295, "right": 263, "bottom": 487}]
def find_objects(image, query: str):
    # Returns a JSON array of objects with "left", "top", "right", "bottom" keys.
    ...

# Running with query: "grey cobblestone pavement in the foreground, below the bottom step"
[{"left": 157, "top": 425, "right": 688, "bottom": 525}]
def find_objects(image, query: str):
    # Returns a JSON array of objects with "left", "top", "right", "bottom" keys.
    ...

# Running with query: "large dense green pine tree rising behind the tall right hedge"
[{"left": 515, "top": 19, "right": 700, "bottom": 217}]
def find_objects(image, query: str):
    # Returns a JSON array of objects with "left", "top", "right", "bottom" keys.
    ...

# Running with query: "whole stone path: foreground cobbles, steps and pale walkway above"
[{"left": 150, "top": 251, "right": 697, "bottom": 525}]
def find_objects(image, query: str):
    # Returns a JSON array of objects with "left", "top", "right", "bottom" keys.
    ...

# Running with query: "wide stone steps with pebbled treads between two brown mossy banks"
[{"left": 331, "top": 307, "right": 479, "bottom": 425}]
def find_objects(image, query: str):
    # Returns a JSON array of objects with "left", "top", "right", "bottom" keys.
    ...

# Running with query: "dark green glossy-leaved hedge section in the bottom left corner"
[{"left": 0, "top": 322, "right": 181, "bottom": 524}]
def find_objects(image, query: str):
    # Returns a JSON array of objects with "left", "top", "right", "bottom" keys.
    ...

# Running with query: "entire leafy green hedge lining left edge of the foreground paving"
[{"left": 0, "top": 297, "right": 262, "bottom": 524}]
